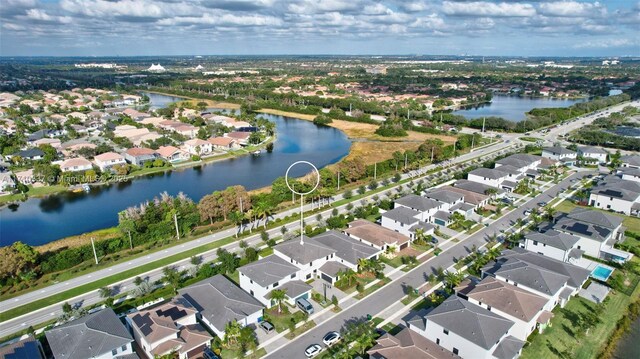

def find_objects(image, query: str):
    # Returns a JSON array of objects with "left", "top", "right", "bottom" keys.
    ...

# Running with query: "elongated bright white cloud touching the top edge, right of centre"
[{"left": 442, "top": 1, "right": 536, "bottom": 17}]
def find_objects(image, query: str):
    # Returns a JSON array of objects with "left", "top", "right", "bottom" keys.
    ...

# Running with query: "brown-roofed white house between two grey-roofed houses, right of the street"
[{"left": 457, "top": 276, "right": 553, "bottom": 341}]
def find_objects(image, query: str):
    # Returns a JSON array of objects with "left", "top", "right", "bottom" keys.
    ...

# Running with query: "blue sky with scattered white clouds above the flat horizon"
[{"left": 0, "top": 0, "right": 640, "bottom": 56}]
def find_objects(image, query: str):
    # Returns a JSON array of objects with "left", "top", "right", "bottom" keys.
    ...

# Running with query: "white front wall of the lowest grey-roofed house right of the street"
[{"left": 409, "top": 320, "right": 498, "bottom": 359}]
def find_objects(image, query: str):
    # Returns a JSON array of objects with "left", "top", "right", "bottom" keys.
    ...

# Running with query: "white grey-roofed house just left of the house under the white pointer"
[{"left": 238, "top": 254, "right": 301, "bottom": 307}]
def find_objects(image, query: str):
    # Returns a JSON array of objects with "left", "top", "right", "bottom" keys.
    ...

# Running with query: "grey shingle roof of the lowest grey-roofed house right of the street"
[{"left": 426, "top": 295, "right": 515, "bottom": 349}]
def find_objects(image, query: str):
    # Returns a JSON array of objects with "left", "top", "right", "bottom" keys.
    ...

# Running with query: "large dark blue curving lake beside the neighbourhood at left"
[{"left": 0, "top": 94, "right": 351, "bottom": 246}]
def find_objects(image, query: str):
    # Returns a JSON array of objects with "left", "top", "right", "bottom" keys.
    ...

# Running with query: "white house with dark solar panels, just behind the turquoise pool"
[{"left": 553, "top": 207, "right": 630, "bottom": 261}]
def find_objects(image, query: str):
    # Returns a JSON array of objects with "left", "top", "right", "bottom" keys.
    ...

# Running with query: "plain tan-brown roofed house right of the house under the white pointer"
[{"left": 344, "top": 219, "right": 410, "bottom": 251}]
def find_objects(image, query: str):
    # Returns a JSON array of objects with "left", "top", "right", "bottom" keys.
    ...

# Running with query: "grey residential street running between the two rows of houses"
[{"left": 267, "top": 172, "right": 592, "bottom": 359}]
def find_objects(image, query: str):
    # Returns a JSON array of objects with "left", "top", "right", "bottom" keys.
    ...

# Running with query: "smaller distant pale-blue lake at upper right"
[{"left": 453, "top": 95, "right": 585, "bottom": 122}]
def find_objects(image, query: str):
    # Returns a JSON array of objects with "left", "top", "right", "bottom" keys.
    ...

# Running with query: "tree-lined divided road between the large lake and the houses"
[{"left": 0, "top": 142, "right": 514, "bottom": 337}]
